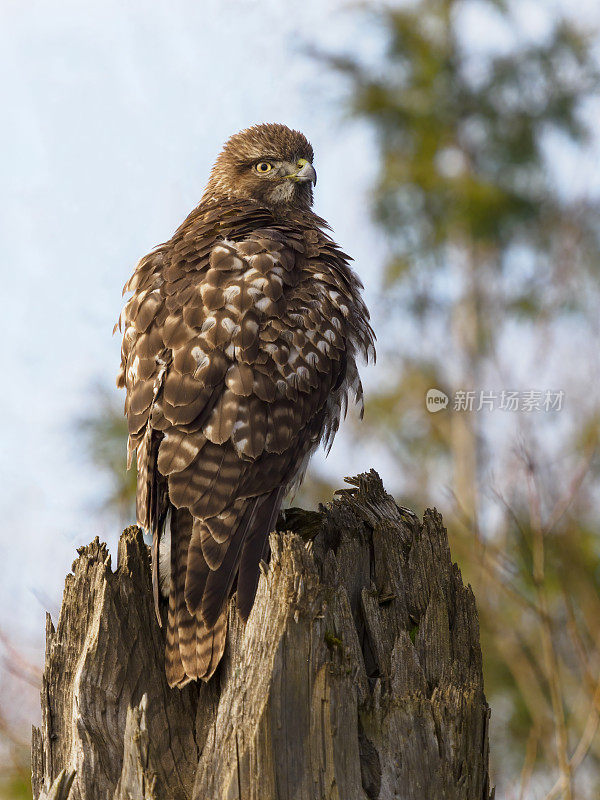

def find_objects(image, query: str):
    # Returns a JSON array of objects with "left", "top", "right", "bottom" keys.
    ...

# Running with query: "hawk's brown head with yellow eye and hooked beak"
[{"left": 203, "top": 124, "right": 317, "bottom": 210}]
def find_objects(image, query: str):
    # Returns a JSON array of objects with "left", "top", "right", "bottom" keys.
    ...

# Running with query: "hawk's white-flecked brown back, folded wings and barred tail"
[{"left": 122, "top": 223, "right": 360, "bottom": 683}]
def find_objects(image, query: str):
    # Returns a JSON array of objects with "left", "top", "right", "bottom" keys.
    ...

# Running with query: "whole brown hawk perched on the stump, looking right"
[{"left": 117, "top": 124, "right": 374, "bottom": 687}]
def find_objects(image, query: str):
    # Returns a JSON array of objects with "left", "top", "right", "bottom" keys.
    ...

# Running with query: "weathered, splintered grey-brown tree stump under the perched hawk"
[{"left": 33, "top": 472, "right": 493, "bottom": 800}]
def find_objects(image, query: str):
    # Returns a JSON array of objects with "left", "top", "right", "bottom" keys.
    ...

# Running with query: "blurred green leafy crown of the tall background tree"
[{"left": 336, "top": 0, "right": 598, "bottom": 260}]
